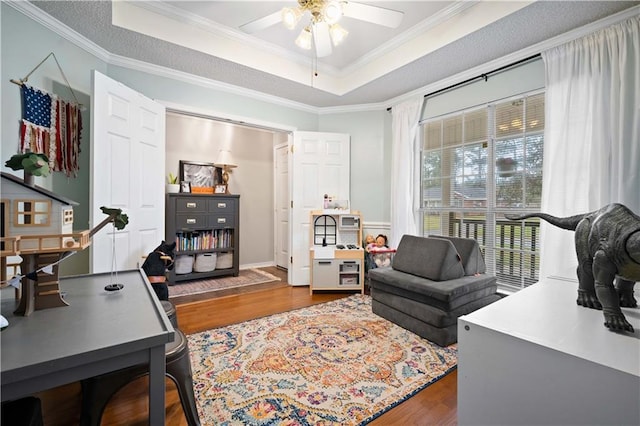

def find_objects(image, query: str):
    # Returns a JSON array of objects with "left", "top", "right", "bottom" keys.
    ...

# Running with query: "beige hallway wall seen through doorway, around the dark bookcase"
[{"left": 165, "top": 106, "right": 289, "bottom": 269}]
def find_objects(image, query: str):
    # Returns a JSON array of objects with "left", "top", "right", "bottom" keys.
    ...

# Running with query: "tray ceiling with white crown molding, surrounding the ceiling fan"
[{"left": 27, "top": 1, "right": 639, "bottom": 108}]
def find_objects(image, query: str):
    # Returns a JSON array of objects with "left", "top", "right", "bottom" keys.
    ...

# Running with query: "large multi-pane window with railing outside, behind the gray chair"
[{"left": 420, "top": 93, "right": 544, "bottom": 288}]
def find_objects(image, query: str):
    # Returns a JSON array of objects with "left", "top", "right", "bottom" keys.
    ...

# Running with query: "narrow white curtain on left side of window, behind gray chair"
[{"left": 389, "top": 96, "right": 424, "bottom": 247}]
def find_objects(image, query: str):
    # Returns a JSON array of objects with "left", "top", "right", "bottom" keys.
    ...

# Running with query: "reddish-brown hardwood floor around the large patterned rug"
[{"left": 38, "top": 268, "right": 457, "bottom": 426}]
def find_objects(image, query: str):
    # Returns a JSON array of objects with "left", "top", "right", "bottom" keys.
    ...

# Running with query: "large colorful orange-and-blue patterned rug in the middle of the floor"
[{"left": 188, "top": 295, "right": 457, "bottom": 425}]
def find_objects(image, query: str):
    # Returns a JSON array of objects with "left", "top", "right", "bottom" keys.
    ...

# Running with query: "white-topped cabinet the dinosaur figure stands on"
[{"left": 458, "top": 278, "right": 640, "bottom": 425}]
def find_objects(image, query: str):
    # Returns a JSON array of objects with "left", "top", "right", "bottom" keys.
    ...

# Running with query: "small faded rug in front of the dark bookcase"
[{"left": 169, "top": 269, "right": 280, "bottom": 297}]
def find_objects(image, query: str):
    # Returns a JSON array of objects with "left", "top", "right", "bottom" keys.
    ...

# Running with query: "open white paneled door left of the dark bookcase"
[{"left": 90, "top": 71, "right": 165, "bottom": 273}]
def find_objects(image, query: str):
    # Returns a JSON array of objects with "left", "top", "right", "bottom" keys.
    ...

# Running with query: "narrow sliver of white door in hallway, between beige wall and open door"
[{"left": 274, "top": 144, "right": 290, "bottom": 269}]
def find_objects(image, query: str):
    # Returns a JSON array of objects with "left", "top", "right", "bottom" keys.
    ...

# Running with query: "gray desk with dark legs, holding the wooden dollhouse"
[{"left": 0, "top": 269, "right": 174, "bottom": 425}]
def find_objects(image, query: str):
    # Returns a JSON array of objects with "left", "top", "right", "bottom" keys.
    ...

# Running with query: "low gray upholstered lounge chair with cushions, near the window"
[{"left": 369, "top": 235, "right": 500, "bottom": 346}]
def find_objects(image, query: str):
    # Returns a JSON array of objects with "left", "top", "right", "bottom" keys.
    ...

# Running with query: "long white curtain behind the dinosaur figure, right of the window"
[{"left": 540, "top": 17, "right": 640, "bottom": 280}]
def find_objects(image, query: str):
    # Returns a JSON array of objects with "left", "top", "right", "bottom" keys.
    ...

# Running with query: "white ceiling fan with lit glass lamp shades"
[{"left": 240, "top": 0, "right": 404, "bottom": 58}]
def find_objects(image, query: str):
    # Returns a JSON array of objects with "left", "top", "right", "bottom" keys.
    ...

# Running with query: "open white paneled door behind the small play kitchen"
[{"left": 288, "top": 132, "right": 350, "bottom": 285}]
